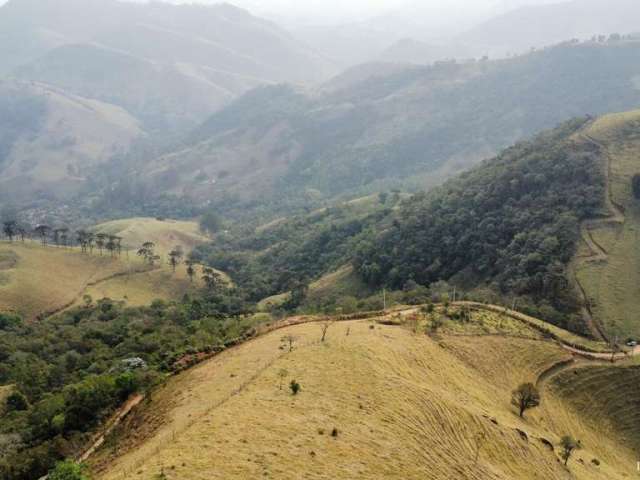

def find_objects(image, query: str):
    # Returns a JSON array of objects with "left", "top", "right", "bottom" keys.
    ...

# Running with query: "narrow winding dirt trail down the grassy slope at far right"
[{"left": 569, "top": 133, "right": 625, "bottom": 341}]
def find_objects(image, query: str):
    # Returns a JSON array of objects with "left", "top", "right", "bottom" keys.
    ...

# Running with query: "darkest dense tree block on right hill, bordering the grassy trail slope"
[{"left": 354, "top": 119, "right": 604, "bottom": 329}]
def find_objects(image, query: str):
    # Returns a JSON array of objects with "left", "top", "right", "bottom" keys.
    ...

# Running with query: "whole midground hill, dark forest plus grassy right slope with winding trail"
[{"left": 196, "top": 113, "right": 640, "bottom": 341}]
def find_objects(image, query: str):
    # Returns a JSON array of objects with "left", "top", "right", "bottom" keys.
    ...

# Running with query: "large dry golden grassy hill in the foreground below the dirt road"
[{"left": 93, "top": 314, "right": 637, "bottom": 480}]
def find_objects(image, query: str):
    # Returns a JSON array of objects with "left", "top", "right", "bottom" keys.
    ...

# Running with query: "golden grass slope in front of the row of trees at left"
[{"left": 0, "top": 242, "right": 200, "bottom": 320}]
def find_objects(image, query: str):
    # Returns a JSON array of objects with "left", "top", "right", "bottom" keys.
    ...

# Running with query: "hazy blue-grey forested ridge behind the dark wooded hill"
[{"left": 139, "top": 41, "right": 640, "bottom": 219}]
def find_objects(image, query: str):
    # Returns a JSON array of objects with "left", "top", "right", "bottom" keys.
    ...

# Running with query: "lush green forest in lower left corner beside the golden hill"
[{"left": 0, "top": 289, "right": 252, "bottom": 480}]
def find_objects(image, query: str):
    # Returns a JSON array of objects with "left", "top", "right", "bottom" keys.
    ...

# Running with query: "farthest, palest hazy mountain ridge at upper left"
[{"left": 0, "top": 0, "right": 335, "bottom": 131}]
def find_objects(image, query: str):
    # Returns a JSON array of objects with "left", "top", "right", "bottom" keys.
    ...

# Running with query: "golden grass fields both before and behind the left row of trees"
[{"left": 0, "top": 219, "right": 215, "bottom": 320}]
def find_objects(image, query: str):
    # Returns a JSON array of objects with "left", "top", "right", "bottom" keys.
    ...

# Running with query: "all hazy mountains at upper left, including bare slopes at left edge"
[{"left": 0, "top": 0, "right": 336, "bottom": 200}]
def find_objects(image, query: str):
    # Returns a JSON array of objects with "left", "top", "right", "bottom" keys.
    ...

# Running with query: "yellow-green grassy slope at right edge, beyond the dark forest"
[{"left": 577, "top": 111, "right": 640, "bottom": 337}]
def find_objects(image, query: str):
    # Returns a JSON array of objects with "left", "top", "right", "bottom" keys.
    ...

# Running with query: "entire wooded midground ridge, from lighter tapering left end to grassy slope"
[{"left": 199, "top": 118, "right": 616, "bottom": 332}]
